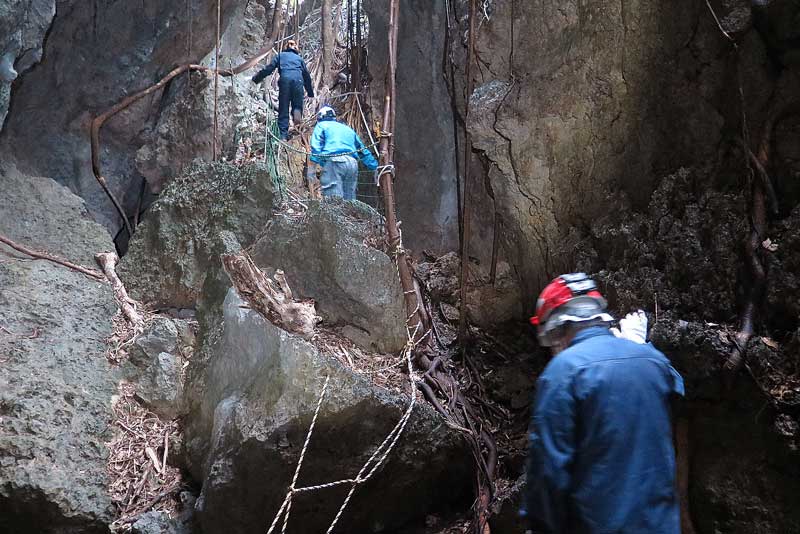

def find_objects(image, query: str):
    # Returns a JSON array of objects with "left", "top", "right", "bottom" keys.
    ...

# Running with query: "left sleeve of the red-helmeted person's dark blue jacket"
[{"left": 525, "top": 370, "right": 576, "bottom": 533}]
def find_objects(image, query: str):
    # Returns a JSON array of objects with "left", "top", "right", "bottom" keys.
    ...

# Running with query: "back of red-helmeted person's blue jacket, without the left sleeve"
[{"left": 542, "top": 327, "right": 683, "bottom": 534}]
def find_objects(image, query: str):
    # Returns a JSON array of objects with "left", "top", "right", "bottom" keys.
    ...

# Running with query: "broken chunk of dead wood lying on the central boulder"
[{"left": 222, "top": 252, "right": 319, "bottom": 339}]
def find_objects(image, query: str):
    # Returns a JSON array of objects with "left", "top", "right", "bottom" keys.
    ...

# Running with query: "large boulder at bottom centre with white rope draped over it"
[{"left": 186, "top": 289, "right": 471, "bottom": 534}]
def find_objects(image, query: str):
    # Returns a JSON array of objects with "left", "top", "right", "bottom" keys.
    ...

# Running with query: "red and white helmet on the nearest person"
[{"left": 530, "top": 273, "right": 614, "bottom": 347}]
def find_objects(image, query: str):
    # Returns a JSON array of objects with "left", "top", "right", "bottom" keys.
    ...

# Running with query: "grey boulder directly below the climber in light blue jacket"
[{"left": 251, "top": 199, "right": 407, "bottom": 352}]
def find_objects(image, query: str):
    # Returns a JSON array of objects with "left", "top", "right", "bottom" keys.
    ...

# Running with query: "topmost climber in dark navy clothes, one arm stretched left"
[{"left": 253, "top": 39, "right": 314, "bottom": 139}]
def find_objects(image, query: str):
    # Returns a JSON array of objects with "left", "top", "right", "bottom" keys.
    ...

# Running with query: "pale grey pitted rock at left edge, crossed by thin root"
[{"left": 0, "top": 166, "right": 116, "bottom": 534}]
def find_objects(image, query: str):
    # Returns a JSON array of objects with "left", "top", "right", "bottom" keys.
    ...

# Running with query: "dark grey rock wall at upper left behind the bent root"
[{"left": 0, "top": 0, "right": 264, "bottom": 241}]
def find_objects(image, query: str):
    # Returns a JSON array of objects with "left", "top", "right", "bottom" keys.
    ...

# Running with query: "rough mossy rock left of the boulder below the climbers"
[{"left": 119, "top": 162, "right": 278, "bottom": 308}]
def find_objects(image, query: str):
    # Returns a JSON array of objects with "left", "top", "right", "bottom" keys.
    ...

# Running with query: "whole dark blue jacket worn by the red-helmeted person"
[{"left": 524, "top": 326, "right": 683, "bottom": 534}]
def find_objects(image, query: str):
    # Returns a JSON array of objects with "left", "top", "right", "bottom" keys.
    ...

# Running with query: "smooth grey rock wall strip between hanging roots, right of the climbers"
[{"left": 363, "top": 0, "right": 463, "bottom": 255}]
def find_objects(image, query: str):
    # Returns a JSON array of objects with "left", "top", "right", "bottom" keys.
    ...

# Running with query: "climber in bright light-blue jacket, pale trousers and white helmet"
[{"left": 311, "top": 106, "right": 378, "bottom": 200}]
